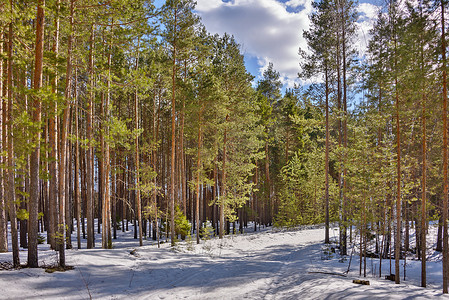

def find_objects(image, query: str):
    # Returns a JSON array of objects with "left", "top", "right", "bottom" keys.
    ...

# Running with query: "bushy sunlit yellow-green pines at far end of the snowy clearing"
[{"left": 274, "top": 93, "right": 338, "bottom": 227}]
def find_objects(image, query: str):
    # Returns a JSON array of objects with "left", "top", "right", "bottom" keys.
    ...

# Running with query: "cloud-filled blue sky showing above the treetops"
[{"left": 155, "top": 0, "right": 380, "bottom": 87}]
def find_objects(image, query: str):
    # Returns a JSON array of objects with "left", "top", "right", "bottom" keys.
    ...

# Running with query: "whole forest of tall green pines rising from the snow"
[{"left": 0, "top": 0, "right": 449, "bottom": 292}]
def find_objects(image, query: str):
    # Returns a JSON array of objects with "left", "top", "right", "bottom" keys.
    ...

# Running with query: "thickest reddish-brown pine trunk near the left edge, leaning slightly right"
[{"left": 28, "top": 0, "right": 45, "bottom": 268}]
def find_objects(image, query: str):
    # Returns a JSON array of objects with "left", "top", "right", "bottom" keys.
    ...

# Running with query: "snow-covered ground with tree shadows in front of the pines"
[{"left": 0, "top": 224, "right": 449, "bottom": 300}]
